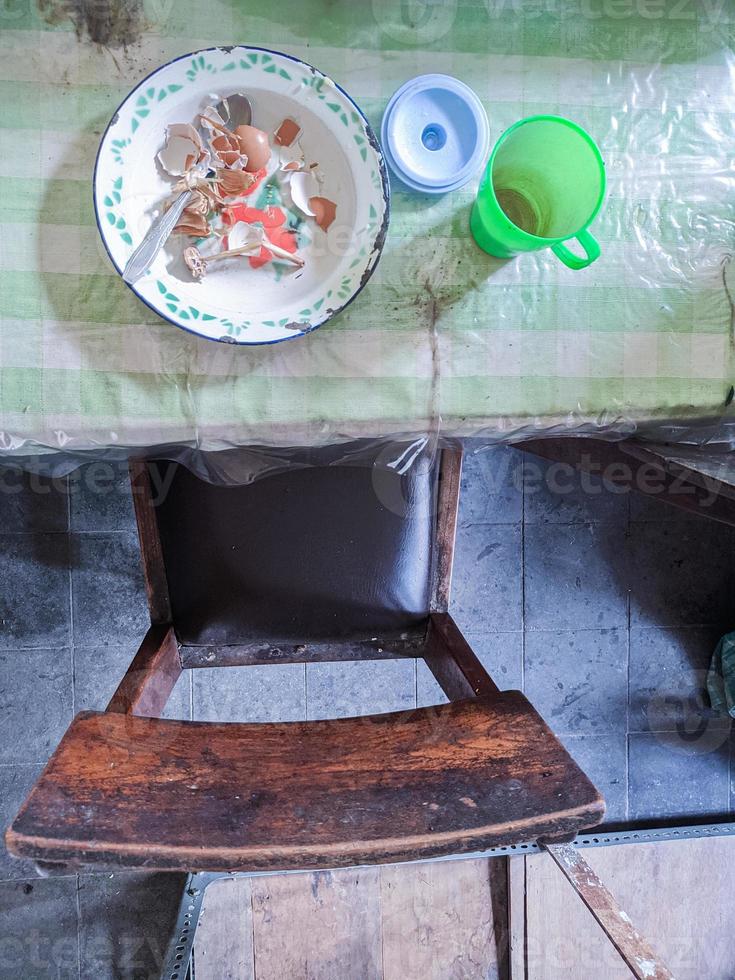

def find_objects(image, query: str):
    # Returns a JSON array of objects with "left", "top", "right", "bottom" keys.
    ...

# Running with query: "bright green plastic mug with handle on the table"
[{"left": 470, "top": 116, "right": 605, "bottom": 269}]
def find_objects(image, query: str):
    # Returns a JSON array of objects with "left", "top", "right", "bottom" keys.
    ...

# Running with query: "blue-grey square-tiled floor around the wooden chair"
[{"left": 0, "top": 448, "right": 735, "bottom": 980}]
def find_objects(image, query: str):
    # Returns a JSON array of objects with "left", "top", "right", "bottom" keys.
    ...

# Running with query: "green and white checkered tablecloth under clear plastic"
[{"left": 0, "top": 0, "right": 735, "bottom": 455}]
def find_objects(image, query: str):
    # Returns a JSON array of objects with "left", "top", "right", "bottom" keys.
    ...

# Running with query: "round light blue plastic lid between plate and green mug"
[{"left": 381, "top": 75, "right": 490, "bottom": 194}]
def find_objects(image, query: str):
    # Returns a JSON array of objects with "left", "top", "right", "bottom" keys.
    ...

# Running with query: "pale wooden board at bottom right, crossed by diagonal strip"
[{"left": 528, "top": 837, "right": 735, "bottom": 980}]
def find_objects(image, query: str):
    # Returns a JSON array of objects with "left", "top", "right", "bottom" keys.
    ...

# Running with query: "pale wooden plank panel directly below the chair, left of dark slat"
[{"left": 194, "top": 860, "right": 507, "bottom": 980}]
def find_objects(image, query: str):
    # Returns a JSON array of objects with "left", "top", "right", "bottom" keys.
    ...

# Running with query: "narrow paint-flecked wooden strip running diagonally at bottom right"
[{"left": 544, "top": 843, "right": 674, "bottom": 980}]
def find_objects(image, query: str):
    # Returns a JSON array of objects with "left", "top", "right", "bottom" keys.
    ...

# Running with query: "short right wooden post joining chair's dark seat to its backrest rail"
[{"left": 423, "top": 613, "right": 499, "bottom": 701}]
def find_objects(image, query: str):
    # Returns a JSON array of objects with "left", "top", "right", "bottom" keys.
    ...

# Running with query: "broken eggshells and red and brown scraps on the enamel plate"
[{"left": 157, "top": 99, "right": 337, "bottom": 279}]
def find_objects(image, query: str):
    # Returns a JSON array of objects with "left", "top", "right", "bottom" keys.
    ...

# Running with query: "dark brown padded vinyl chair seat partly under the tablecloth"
[{"left": 150, "top": 446, "right": 437, "bottom": 645}]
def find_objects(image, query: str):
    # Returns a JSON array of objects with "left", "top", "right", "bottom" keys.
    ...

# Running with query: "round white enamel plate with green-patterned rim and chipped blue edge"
[{"left": 94, "top": 46, "right": 390, "bottom": 344}]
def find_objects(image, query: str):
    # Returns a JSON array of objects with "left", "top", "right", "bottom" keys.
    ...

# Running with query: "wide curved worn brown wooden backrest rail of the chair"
[{"left": 8, "top": 691, "right": 604, "bottom": 871}]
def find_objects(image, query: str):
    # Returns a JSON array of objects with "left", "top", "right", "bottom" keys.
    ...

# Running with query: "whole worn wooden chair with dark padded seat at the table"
[{"left": 6, "top": 440, "right": 604, "bottom": 871}]
